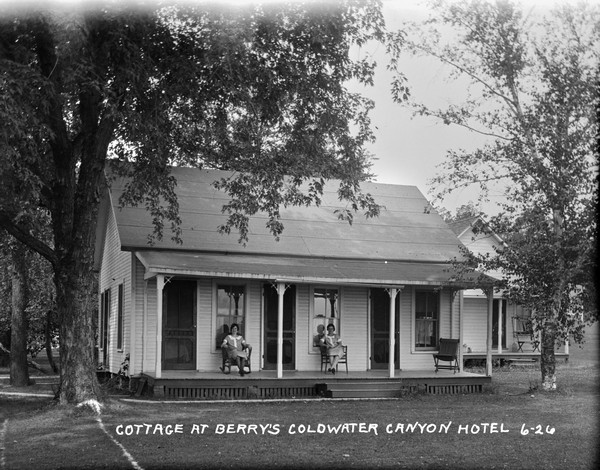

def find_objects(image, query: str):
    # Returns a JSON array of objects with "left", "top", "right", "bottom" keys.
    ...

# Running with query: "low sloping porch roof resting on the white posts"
[{"left": 136, "top": 250, "right": 488, "bottom": 288}]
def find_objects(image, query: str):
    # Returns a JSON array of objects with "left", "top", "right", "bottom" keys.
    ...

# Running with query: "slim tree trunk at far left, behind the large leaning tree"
[{"left": 10, "top": 242, "right": 30, "bottom": 387}]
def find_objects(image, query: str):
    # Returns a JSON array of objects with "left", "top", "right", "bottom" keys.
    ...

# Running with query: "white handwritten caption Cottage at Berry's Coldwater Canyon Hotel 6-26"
[{"left": 115, "top": 421, "right": 556, "bottom": 436}]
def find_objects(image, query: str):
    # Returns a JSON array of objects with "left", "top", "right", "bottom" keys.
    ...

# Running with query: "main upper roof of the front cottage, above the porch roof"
[{"left": 111, "top": 168, "right": 461, "bottom": 263}]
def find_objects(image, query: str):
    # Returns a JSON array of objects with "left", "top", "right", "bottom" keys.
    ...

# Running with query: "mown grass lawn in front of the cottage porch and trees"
[{"left": 0, "top": 361, "right": 600, "bottom": 470}]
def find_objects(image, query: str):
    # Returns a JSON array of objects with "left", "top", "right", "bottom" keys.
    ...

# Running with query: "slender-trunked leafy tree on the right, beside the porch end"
[{"left": 392, "top": 0, "right": 600, "bottom": 390}]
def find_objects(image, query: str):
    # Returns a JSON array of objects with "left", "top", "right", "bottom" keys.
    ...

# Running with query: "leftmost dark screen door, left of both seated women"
[{"left": 162, "top": 279, "right": 196, "bottom": 370}]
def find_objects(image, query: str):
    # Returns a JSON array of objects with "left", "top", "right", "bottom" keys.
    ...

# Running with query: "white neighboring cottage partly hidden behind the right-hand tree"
[{"left": 449, "top": 216, "right": 568, "bottom": 359}]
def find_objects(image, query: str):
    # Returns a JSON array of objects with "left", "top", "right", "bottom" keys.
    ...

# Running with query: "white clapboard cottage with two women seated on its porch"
[{"left": 97, "top": 168, "right": 489, "bottom": 393}]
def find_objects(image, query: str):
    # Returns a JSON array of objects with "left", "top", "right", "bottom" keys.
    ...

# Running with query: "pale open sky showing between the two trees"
[{"left": 346, "top": 0, "right": 584, "bottom": 215}]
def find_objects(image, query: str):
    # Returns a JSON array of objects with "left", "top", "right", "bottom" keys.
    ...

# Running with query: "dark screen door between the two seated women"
[{"left": 263, "top": 284, "right": 296, "bottom": 370}]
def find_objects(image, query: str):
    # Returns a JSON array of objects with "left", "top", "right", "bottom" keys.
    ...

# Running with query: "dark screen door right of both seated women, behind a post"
[{"left": 371, "top": 289, "right": 400, "bottom": 369}]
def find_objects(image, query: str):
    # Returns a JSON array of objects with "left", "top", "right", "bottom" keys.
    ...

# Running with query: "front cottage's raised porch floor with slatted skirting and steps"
[{"left": 138, "top": 369, "right": 492, "bottom": 400}]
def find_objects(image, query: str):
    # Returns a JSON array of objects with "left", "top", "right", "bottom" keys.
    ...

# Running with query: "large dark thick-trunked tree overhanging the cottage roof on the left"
[{"left": 0, "top": 0, "right": 383, "bottom": 403}]
